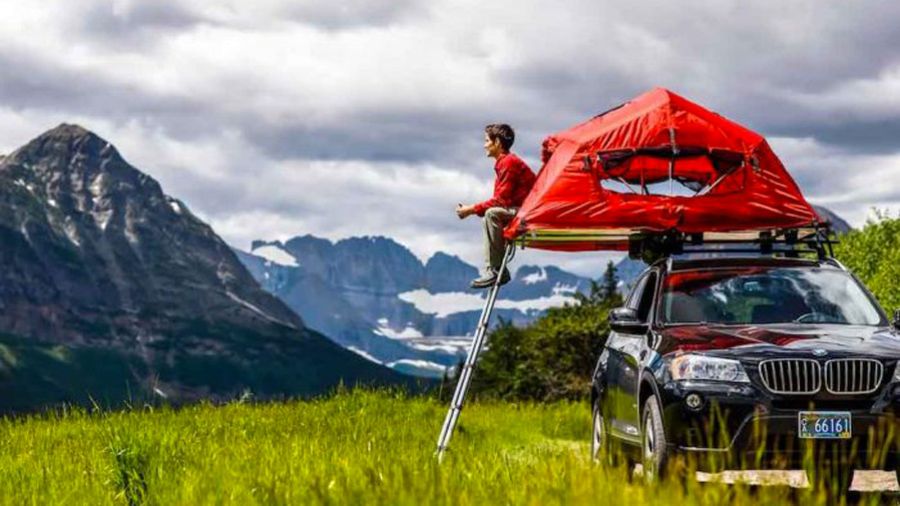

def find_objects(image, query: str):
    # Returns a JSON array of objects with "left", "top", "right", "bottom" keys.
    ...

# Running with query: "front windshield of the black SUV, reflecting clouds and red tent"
[{"left": 660, "top": 266, "right": 882, "bottom": 325}]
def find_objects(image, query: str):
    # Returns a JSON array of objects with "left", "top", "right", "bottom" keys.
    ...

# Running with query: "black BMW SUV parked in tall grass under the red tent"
[{"left": 591, "top": 256, "right": 900, "bottom": 486}]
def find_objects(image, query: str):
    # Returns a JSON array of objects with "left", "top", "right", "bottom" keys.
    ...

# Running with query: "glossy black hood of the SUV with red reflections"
[{"left": 657, "top": 324, "right": 900, "bottom": 359}]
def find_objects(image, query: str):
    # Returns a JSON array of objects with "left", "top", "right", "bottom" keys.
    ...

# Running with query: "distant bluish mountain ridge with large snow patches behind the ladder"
[{"left": 236, "top": 235, "right": 590, "bottom": 375}]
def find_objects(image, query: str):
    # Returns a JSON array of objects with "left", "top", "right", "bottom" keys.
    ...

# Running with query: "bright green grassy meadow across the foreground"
[{"left": 0, "top": 391, "right": 893, "bottom": 506}]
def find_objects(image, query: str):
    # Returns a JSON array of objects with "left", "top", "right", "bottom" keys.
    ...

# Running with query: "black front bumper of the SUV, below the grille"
[{"left": 660, "top": 381, "right": 900, "bottom": 470}]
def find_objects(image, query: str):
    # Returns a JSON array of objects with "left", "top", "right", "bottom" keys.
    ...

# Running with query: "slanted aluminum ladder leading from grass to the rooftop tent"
[{"left": 435, "top": 242, "right": 516, "bottom": 462}]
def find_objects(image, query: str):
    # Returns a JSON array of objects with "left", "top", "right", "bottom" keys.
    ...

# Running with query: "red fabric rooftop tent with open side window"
[{"left": 505, "top": 88, "right": 819, "bottom": 251}]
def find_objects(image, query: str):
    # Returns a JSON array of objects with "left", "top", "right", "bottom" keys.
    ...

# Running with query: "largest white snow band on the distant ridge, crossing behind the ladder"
[{"left": 398, "top": 289, "right": 575, "bottom": 318}]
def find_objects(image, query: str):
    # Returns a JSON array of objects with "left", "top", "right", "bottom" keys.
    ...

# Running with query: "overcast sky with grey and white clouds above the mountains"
[{"left": 0, "top": 0, "right": 900, "bottom": 276}]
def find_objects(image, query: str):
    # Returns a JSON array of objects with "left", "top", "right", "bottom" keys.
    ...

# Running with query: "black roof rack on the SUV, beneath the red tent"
[{"left": 628, "top": 224, "right": 837, "bottom": 264}]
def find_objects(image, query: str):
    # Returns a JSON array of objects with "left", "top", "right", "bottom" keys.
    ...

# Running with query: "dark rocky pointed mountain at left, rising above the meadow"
[{"left": 0, "top": 124, "right": 406, "bottom": 411}]
